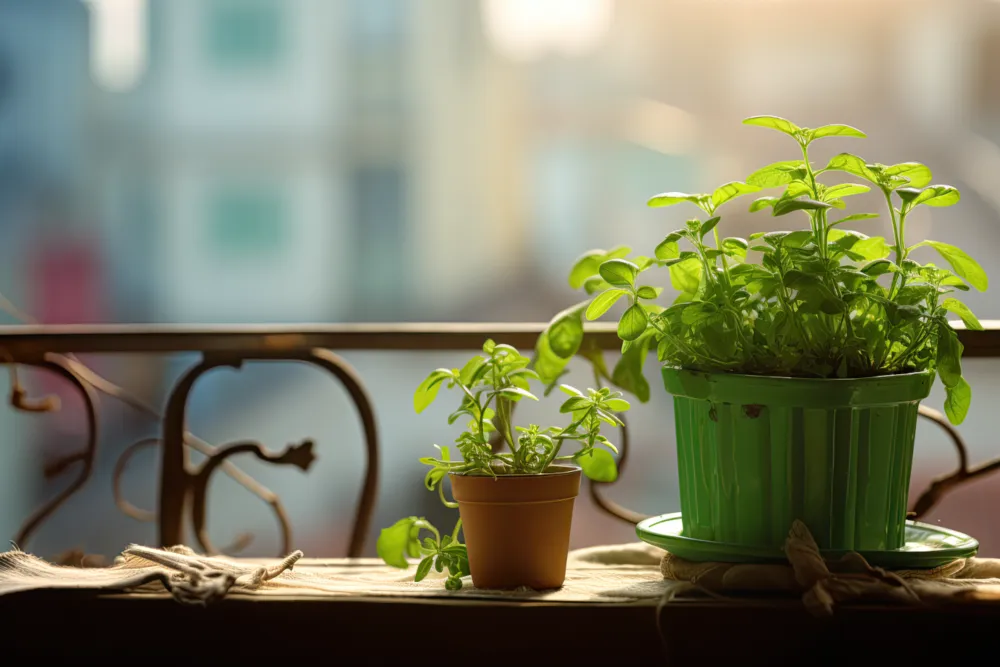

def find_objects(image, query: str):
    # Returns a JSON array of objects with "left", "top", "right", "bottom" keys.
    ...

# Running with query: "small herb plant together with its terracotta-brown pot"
[{"left": 377, "top": 340, "right": 629, "bottom": 589}]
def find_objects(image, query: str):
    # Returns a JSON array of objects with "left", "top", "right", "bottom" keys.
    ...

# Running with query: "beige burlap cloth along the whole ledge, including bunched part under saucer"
[{"left": 0, "top": 523, "right": 1000, "bottom": 614}]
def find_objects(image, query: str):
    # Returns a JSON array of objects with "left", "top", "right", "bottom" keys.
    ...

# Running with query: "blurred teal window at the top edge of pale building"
[{"left": 203, "top": 0, "right": 285, "bottom": 67}]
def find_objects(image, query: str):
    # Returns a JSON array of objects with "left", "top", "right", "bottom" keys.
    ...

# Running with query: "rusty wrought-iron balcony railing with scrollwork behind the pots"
[{"left": 0, "top": 321, "right": 1000, "bottom": 556}]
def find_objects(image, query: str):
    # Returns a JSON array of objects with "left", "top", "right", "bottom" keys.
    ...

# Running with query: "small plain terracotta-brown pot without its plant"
[{"left": 450, "top": 466, "right": 580, "bottom": 590}]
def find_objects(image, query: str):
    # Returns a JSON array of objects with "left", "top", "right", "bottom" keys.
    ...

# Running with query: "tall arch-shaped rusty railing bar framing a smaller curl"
[{"left": 159, "top": 349, "right": 379, "bottom": 557}]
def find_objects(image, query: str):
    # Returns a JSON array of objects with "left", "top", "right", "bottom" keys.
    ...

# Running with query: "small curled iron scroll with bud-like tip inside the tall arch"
[{"left": 191, "top": 439, "right": 316, "bottom": 555}]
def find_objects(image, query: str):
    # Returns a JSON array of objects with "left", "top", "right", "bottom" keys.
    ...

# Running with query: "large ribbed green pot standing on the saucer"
[{"left": 663, "top": 367, "right": 934, "bottom": 549}]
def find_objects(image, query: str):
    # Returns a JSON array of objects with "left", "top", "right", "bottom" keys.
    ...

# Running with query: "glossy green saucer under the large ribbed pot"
[{"left": 635, "top": 512, "right": 979, "bottom": 570}]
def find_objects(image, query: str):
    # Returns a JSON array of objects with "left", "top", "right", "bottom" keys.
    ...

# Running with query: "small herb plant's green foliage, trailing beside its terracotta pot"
[{"left": 377, "top": 340, "right": 629, "bottom": 590}]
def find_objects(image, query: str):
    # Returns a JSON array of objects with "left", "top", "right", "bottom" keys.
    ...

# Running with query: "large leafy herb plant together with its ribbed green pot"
[{"left": 536, "top": 116, "right": 988, "bottom": 550}]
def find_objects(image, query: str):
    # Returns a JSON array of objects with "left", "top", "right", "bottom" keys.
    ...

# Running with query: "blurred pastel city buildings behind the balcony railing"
[{"left": 0, "top": 0, "right": 1000, "bottom": 556}]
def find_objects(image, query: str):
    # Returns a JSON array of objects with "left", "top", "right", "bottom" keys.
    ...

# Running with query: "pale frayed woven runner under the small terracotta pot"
[{"left": 0, "top": 544, "right": 670, "bottom": 604}]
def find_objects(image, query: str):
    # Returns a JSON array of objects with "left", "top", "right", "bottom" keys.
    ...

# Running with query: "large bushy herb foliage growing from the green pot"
[{"left": 535, "top": 116, "right": 988, "bottom": 424}]
